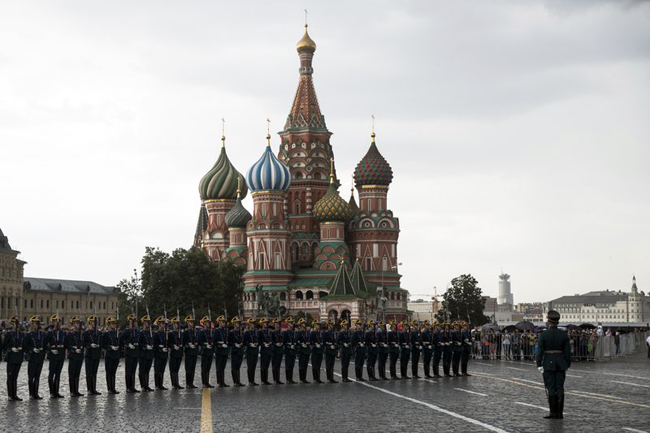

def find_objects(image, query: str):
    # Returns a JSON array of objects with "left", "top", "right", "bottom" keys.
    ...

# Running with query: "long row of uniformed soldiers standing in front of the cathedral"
[{"left": 1, "top": 314, "right": 472, "bottom": 402}]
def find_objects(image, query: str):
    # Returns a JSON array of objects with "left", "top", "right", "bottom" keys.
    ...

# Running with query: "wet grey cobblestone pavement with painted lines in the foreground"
[{"left": 0, "top": 354, "right": 650, "bottom": 433}]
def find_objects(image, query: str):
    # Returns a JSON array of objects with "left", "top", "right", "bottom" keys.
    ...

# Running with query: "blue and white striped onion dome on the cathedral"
[{"left": 246, "top": 135, "right": 291, "bottom": 192}]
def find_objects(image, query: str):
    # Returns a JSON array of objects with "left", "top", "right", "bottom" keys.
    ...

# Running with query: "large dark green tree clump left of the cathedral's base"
[{"left": 118, "top": 247, "right": 244, "bottom": 321}]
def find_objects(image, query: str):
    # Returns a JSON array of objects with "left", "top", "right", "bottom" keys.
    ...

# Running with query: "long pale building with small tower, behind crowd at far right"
[{"left": 548, "top": 276, "right": 650, "bottom": 325}]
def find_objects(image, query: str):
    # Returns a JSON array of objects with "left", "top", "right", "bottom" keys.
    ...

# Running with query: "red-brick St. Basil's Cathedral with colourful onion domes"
[{"left": 194, "top": 25, "right": 408, "bottom": 320}]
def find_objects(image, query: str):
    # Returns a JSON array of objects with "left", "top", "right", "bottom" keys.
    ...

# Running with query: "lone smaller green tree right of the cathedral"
[{"left": 436, "top": 274, "right": 490, "bottom": 325}]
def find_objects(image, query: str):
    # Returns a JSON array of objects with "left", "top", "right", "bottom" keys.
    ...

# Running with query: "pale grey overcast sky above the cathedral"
[{"left": 0, "top": 0, "right": 650, "bottom": 302}]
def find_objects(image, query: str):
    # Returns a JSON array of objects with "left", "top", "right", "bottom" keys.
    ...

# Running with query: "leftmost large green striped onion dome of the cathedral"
[{"left": 199, "top": 136, "right": 248, "bottom": 200}]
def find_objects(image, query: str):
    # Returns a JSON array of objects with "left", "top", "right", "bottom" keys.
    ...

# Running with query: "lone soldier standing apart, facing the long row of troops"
[{"left": 536, "top": 310, "right": 571, "bottom": 419}]
